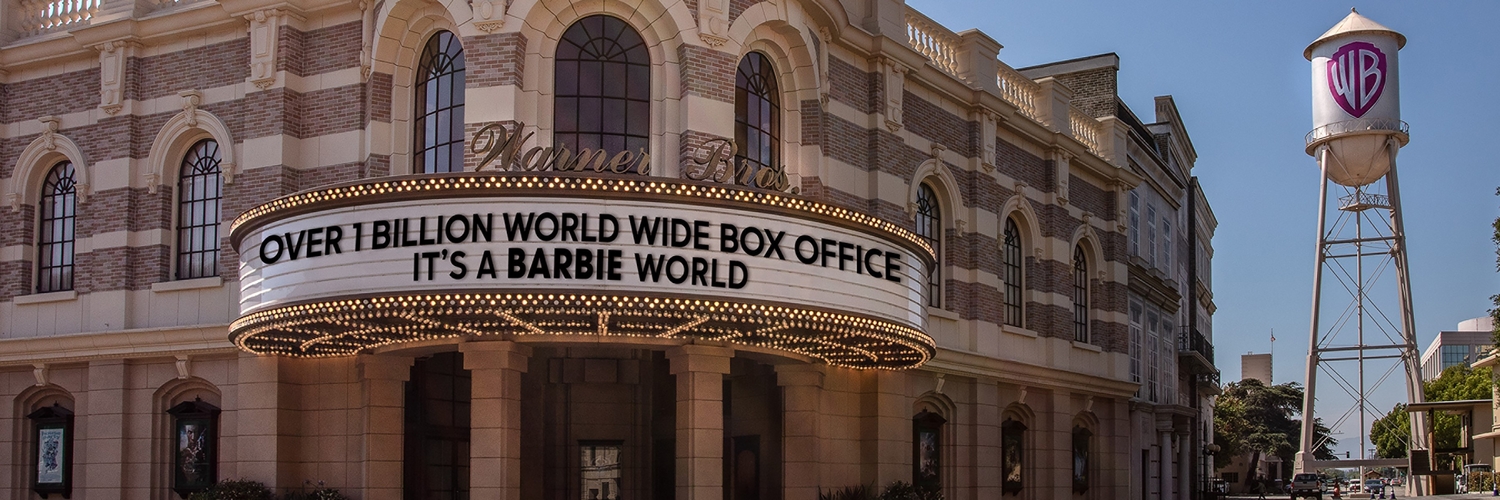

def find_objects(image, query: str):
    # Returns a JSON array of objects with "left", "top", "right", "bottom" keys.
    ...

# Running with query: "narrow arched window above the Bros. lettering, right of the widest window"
[{"left": 735, "top": 53, "right": 782, "bottom": 171}]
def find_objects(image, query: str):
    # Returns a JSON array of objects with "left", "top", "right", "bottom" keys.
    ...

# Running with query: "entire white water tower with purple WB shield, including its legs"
[{"left": 1296, "top": 6, "right": 1428, "bottom": 488}]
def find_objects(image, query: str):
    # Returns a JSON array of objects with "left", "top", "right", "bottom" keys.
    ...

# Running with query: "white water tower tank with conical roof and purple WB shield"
[{"left": 1302, "top": 11, "right": 1407, "bottom": 186}]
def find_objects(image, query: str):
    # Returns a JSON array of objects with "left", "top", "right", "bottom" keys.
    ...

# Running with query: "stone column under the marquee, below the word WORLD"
[{"left": 666, "top": 345, "right": 734, "bottom": 500}]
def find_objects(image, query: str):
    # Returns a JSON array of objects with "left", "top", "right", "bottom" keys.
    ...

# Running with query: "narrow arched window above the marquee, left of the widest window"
[{"left": 411, "top": 32, "right": 464, "bottom": 174}]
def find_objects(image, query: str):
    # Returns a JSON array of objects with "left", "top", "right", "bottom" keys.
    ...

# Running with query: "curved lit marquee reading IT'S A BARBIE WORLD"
[{"left": 231, "top": 173, "right": 933, "bottom": 368}]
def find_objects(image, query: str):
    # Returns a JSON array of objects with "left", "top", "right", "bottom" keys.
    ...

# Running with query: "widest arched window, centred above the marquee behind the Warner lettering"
[{"left": 552, "top": 15, "right": 651, "bottom": 152}]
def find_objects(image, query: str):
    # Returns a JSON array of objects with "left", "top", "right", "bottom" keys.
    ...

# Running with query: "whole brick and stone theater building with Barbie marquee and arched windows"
[{"left": 0, "top": 0, "right": 1202, "bottom": 500}]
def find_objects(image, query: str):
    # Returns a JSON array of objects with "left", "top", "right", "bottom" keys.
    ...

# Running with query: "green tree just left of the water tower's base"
[{"left": 1214, "top": 378, "right": 1338, "bottom": 477}]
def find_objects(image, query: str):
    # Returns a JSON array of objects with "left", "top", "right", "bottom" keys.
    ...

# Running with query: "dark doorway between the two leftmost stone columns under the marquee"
[{"left": 404, "top": 353, "right": 470, "bottom": 500}]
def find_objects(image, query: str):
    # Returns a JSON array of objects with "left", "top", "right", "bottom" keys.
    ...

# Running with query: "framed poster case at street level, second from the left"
[{"left": 167, "top": 398, "right": 219, "bottom": 498}]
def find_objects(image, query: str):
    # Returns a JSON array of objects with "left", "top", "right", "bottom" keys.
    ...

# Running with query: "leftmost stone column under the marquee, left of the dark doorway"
[{"left": 358, "top": 354, "right": 413, "bottom": 500}]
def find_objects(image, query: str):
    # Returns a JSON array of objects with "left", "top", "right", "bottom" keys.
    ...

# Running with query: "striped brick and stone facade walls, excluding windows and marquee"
[{"left": 0, "top": 0, "right": 1212, "bottom": 500}]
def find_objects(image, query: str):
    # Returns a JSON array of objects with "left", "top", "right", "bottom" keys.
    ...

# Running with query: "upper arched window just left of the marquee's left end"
[{"left": 177, "top": 140, "right": 224, "bottom": 279}]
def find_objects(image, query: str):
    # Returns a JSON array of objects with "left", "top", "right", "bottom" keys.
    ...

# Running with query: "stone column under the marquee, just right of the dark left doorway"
[{"left": 459, "top": 341, "right": 531, "bottom": 500}]
